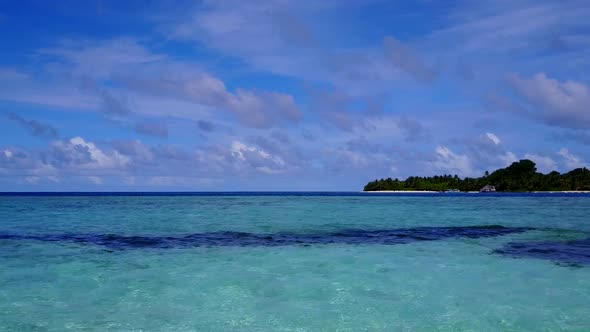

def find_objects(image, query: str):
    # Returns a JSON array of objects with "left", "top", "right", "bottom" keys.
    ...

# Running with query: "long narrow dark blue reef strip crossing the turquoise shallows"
[{"left": 0, "top": 225, "right": 532, "bottom": 250}]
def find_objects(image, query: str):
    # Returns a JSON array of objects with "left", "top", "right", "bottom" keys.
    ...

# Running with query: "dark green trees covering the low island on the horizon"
[{"left": 364, "top": 159, "right": 590, "bottom": 191}]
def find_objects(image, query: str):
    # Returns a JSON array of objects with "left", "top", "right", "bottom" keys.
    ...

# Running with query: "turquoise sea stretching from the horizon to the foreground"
[{"left": 0, "top": 194, "right": 590, "bottom": 331}]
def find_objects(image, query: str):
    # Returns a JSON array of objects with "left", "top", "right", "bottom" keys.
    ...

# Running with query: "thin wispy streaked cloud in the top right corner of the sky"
[{"left": 430, "top": 1, "right": 590, "bottom": 55}]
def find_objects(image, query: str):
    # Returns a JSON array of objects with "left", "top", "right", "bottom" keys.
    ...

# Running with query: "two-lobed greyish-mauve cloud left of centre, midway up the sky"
[{"left": 124, "top": 69, "right": 302, "bottom": 128}]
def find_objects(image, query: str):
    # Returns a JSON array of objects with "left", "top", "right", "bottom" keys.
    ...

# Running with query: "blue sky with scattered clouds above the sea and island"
[{"left": 0, "top": 0, "right": 590, "bottom": 191}]
